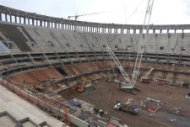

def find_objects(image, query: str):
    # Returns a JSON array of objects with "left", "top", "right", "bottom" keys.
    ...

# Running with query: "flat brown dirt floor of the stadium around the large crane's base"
[{"left": 62, "top": 80, "right": 190, "bottom": 127}]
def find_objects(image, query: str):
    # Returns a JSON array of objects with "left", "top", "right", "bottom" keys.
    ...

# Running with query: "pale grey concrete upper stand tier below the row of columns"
[{"left": 0, "top": 23, "right": 190, "bottom": 55}]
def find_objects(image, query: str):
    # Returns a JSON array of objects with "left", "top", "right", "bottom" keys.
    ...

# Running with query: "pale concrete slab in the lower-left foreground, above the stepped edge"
[{"left": 0, "top": 86, "right": 65, "bottom": 127}]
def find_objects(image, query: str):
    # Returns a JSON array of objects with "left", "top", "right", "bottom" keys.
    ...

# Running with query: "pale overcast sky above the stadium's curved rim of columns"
[{"left": 0, "top": 0, "right": 190, "bottom": 24}]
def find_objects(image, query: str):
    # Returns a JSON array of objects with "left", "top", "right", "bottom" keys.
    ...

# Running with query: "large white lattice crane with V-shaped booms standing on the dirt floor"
[{"left": 107, "top": 0, "right": 154, "bottom": 91}]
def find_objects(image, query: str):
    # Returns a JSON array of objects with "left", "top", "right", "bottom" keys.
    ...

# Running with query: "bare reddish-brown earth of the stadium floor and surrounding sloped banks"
[{"left": 10, "top": 62, "right": 190, "bottom": 127}]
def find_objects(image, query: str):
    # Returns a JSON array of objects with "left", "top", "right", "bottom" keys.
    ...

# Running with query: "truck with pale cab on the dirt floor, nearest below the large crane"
[{"left": 114, "top": 99, "right": 140, "bottom": 115}]
